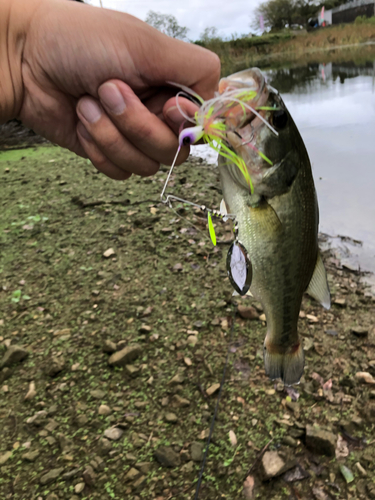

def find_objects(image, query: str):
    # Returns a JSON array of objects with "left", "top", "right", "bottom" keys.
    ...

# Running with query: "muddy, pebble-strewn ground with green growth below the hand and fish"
[{"left": 0, "top": 146, "right": 375, "bottom": 500}]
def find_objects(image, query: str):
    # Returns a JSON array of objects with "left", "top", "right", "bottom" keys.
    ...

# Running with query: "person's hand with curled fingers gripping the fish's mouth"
[{"left": 2, "top": 0, "right": 220, "bottom": 179}]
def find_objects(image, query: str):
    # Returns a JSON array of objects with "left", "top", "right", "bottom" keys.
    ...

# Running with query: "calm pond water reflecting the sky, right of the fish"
[{"left": 192, "top": 54, "right": 375, "bottom": 288}]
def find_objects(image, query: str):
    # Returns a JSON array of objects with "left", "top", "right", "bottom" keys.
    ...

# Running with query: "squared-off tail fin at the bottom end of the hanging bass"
[{"left": 264, "top": 342, "right": 305, "bottom": 385}]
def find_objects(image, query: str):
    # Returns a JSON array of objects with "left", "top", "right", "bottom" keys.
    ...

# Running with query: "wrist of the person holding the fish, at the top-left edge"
[{"left": 0, "top": 0, "right": 42, "bottom": 123}]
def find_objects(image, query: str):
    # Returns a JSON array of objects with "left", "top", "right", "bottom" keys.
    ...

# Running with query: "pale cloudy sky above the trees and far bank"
[{"left": 85, "top": 0, "right": 261, "bottom": 40}]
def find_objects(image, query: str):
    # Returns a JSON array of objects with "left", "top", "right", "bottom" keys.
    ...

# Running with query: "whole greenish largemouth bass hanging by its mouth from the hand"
[{"left": 219, "top": 68, "right": 330, "bottom": 385}]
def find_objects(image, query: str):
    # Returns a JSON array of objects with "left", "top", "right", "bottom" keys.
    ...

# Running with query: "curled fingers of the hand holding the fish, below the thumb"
[{"left": 77, "top": 81, "right": 189, "bottom": 179}]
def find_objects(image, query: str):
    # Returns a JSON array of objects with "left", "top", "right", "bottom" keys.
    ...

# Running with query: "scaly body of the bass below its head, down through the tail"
[{"left": 220, "top": 162, "right": 318, "bottom": 385}]
